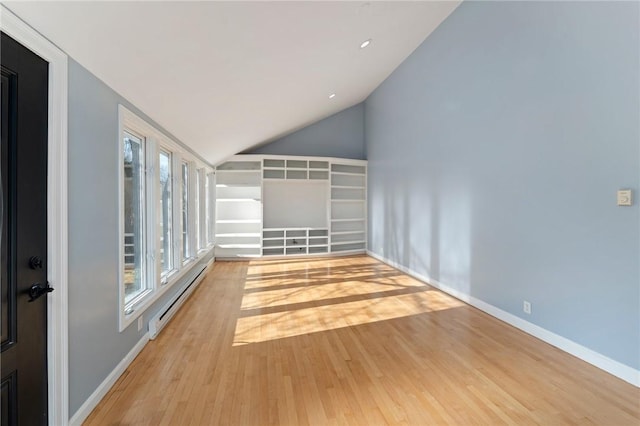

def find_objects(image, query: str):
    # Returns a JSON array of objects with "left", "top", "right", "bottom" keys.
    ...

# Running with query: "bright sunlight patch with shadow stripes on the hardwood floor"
[{"left": 233, "top": 258, "right": 464, "bottom": 346}]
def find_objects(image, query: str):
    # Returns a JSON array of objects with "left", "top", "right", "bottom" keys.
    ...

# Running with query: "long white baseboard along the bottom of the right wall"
[{"left": 367, "top": 250, "right": 640, "bottom": 387}]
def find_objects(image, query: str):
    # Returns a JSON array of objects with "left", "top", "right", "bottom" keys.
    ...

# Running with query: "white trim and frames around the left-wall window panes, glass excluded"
[{"left": 117, "top": 105, "right": 212, "bottom": 332}]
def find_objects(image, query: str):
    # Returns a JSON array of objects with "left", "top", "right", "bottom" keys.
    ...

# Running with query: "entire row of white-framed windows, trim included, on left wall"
[{"left": 117, "top": 106, "right": 211, "bottom": 331}]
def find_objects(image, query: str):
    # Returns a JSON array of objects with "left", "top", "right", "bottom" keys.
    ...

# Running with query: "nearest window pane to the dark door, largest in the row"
[{"left": 122, "top": 132, "right": 149, "bottom": 307}]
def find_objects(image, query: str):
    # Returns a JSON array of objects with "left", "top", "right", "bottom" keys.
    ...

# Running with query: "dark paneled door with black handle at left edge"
[{"left": 0, "top": 33, "right": 50, "bottom": 426}]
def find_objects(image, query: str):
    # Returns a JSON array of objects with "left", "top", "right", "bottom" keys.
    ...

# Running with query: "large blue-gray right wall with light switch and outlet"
[{"left": 365, "top": 2, "right": 640, "bottom": 369}]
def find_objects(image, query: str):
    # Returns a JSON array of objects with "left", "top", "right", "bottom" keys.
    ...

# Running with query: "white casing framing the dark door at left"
[{"left": 0, "top": 5, "right": 69, "bottom": 425}]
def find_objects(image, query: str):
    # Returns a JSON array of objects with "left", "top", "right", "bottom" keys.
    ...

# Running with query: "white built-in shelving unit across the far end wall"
[{"left": 216, "top": 155, "right": 367, "bottom": 258}]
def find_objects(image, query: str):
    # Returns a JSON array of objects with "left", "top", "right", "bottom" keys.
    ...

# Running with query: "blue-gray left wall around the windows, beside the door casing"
[{"left": 68, "top": 60, "right": 214, "bottom": 416}]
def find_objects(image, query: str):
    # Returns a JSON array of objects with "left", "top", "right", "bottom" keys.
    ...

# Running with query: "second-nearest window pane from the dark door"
[{"left": 158, "top": 150, "right": 173, "bottom": 279}]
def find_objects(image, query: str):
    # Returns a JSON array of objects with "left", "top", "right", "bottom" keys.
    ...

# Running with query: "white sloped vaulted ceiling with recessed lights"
[{"left": 4, "top": 1, "right": 459, "bottom": 164}]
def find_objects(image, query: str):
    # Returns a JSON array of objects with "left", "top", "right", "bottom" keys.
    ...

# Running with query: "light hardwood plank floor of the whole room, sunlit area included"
[{"left": 85, "top": 256, "right": 640, "bottom": 425}]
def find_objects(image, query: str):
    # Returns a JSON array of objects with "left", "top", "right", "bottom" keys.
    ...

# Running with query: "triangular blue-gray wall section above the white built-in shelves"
[{"left": 245, "top": 103, "right": 365, "bottom": 160}]
